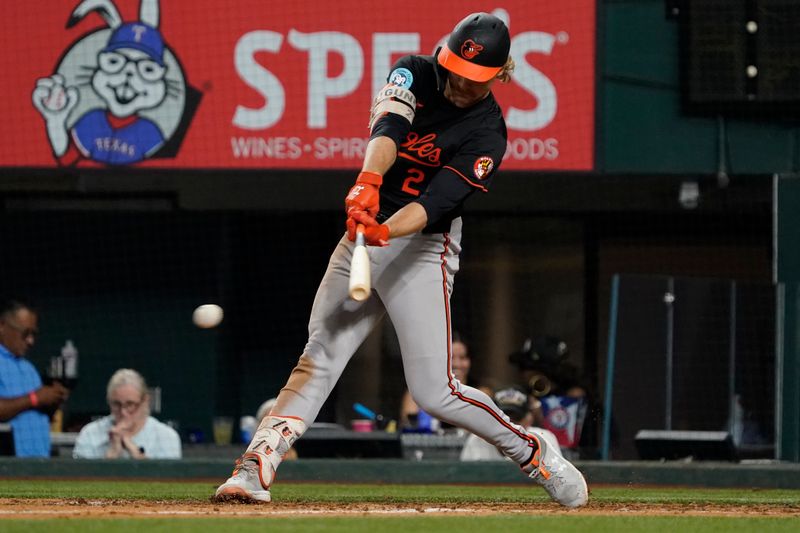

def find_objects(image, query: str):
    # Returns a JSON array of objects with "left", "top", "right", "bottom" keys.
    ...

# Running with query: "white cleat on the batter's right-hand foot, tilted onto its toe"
[{"left": 523, "top": 429, "right": 589, "bottom": 508}]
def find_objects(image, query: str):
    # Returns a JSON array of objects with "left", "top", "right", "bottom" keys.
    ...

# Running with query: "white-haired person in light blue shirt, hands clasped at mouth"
[{"left": 72, "top": 368, "right": 181, "bottom": 459}]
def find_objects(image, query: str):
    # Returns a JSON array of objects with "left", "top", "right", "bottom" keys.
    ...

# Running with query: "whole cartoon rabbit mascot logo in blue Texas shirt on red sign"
[{"left": 33, "top": 0, "right": 200, "bottom": 165}]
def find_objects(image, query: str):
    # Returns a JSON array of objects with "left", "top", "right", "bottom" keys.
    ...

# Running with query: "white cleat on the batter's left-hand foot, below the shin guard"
[{"left": 213, "top": 452, "right": 275, "bottom": 503}]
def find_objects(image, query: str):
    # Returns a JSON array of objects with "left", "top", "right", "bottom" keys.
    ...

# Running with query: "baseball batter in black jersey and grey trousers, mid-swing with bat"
[{"left": 215, "top": 13, "right": 588, "bottom": 507}]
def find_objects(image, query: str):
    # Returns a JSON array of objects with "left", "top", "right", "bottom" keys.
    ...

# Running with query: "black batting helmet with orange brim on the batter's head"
[{"left": 436, "top": 13, "right": 511, "bottom": 83}]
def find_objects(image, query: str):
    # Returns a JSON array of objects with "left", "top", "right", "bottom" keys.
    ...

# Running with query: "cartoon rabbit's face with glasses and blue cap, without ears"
[{"left": 91, "top": 23, "right": 167, "bottom": 117}]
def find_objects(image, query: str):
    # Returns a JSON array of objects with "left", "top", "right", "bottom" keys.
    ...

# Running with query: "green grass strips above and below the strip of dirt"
[{"left": 0, "top": 479, "right": 800, "bottom": 533}]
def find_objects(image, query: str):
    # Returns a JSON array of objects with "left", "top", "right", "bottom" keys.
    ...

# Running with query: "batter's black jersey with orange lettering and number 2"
[{"left": 371, "top": 56, "right": 508, "bottom": 233}]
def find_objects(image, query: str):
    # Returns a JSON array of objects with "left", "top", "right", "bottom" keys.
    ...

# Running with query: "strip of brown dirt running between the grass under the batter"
[{"left": 0, "top": 498, "right": 800, "bottom": 519}]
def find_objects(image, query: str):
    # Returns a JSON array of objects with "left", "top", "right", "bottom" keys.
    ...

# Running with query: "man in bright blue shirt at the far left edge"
[{"left": 0, "top": 300, "right": 69, "bottom": 457}]
